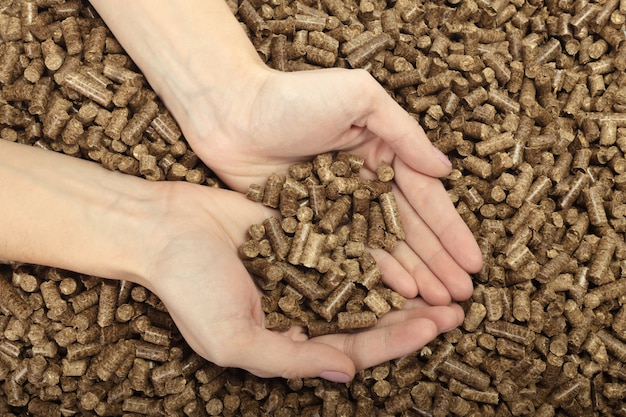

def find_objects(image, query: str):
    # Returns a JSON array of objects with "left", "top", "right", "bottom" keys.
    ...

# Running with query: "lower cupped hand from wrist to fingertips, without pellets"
[{"left": 147, "top": 183, "right": 463, "bottom": 382}]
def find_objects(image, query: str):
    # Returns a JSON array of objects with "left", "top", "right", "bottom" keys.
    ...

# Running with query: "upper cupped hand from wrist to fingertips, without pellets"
[{"left": 181, "top": 69, "right": 482, "bottom": 305}]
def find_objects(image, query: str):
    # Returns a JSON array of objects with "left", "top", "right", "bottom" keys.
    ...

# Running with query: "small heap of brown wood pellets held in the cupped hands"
[{"left": 239, "top": 152, "right": 406, "bottom": 337}]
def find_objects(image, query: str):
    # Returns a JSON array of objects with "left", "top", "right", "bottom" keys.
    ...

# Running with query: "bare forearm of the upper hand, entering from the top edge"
[{"left": 86, "top": 0, "right": 265, "bottom": 140}]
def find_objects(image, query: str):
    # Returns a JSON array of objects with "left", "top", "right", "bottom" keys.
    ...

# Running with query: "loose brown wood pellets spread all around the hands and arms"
[{"left": 0, "top": 0, "right": 626, "bottom": 417}]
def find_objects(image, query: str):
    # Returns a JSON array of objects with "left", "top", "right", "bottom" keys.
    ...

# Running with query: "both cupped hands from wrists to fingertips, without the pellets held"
[{"left": 144, "top": 69, "right": 482, "bottom": 382}]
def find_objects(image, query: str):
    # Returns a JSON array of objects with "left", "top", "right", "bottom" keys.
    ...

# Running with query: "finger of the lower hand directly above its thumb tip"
[{"left": 313, "top": 318, "right": 439, "bottom": 370}]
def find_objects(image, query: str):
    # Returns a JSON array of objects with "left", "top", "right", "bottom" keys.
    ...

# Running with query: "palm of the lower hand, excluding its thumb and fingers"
[{"left": 146, "top": 184, "right": 270, "bottom": 362}]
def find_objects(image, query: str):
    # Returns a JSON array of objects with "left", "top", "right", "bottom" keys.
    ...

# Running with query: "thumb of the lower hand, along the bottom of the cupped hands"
[{"left": 232, "top": 327, "right": 356, "bottom": 383}]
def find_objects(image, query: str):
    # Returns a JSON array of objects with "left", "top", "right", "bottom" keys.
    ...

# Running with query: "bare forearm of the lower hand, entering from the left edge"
[{"left": 0, "top": 140, "right": 158, "bottom": 284}]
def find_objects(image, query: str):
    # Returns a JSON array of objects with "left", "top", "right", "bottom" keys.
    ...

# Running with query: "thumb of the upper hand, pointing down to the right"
[{"left": 352, "top": 72, "right": 451, "bottom": 177}]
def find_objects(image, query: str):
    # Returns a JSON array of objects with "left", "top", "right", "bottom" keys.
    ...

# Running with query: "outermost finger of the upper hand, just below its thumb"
[{"left": 394, "top": 159, "right": 482, "bottom": 272}]
